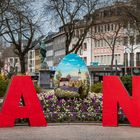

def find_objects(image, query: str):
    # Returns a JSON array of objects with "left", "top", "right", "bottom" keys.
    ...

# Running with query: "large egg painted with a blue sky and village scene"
[{"left": 54, "top": 53, "right": 90, "bottom": 98}]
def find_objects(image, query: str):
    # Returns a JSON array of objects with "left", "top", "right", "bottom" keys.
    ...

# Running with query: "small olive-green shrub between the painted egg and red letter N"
[{"left": 90, "top": 82, "right": 102, "bottom": 93}]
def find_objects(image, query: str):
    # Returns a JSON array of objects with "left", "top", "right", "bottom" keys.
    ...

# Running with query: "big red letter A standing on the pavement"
[{"left": 0, "top": 76, "right": 47, "bottom": 127}]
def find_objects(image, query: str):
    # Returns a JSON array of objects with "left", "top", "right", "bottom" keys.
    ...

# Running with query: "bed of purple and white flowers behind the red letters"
[{"left": 38, "top": 90, "right": 128, "bottom": 123}]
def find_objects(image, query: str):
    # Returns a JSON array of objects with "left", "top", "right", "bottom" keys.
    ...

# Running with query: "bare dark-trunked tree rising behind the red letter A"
[{"left": 3, "top": 0, "right": 40, "bottom": 73}]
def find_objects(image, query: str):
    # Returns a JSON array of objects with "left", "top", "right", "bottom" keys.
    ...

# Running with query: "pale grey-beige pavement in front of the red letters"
[{"left": 0, "top": 124, "right": 140, "bottom": 140}]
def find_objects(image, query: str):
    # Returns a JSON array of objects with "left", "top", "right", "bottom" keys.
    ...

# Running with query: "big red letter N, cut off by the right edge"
[{"left": 103, "top": 76, "right": 140, "bottom": 126}]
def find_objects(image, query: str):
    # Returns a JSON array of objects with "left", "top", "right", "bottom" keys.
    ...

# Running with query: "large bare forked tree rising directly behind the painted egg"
[{"left": 44, "top": 0, "right": 99, "bottom": 54}]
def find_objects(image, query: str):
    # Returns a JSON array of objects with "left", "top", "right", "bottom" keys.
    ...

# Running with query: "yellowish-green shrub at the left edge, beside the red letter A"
[{"left": 0, "top": 75, "right": 9, "bottom": 97}]
